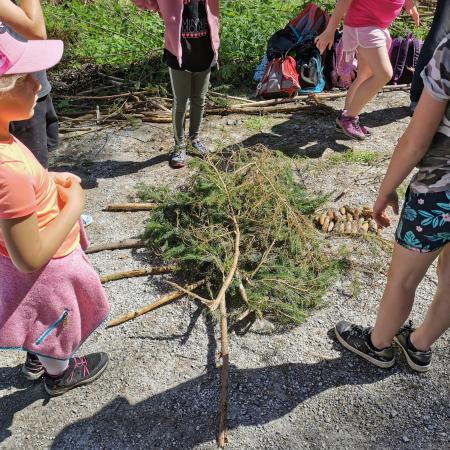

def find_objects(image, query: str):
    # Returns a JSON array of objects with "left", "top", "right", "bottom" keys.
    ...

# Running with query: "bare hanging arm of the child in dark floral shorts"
[{"left": 373, "top": 89, "right": 447, "bottom": 227}]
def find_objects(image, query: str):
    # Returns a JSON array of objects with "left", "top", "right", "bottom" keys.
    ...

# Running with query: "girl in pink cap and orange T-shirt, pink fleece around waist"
[{"left": 0, "top": 29, "right": 109, "bottom": 395}]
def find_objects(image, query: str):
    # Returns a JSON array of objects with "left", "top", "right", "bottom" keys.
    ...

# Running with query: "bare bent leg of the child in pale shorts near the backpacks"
[{"left": 346, "top": 45, "right": 392, "bottom": 117}]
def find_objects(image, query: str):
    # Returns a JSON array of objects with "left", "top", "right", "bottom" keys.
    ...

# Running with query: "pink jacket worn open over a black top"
[{"left": 133, "top": 0, "right": 220, "bottom": 66}]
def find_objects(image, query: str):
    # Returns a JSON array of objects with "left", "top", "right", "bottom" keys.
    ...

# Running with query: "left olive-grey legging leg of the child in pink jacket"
[{"left": 169, "top": 68, "right": 192, "bottom": 144}]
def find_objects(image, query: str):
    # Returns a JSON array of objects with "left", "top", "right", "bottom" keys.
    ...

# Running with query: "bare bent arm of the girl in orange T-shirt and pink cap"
[{"left": 0, "top": 181, "right": 85, "bottom": 272}]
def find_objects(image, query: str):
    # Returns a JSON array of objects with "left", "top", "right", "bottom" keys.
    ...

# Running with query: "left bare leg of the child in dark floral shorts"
[{"left": 371, "top": 243, "right": 439, "bottom": 348}]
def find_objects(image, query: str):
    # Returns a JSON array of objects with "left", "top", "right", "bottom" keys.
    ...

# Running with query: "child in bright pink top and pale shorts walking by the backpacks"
[{"left": 316, "top": 0, "right": 419, "bottom": 140}]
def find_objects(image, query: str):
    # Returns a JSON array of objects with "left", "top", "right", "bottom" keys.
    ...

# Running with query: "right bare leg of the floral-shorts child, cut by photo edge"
[{"left": 410, "top": 244, "right": 450, "bottom": 351}]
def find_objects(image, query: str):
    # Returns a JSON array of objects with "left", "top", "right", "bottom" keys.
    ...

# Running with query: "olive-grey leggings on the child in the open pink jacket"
[{"left": 169, "top": 68, "right": 211, "bottom": 144}]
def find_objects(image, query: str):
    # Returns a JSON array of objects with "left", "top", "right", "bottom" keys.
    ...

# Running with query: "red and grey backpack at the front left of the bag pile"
[{"left": 256, "top": 56, "right": 300, "bottom": 98}]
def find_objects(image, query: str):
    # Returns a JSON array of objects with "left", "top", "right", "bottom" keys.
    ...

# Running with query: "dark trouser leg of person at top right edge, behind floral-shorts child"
[{"left": 410, "top": 0, "right": 450, "bottom": 103}]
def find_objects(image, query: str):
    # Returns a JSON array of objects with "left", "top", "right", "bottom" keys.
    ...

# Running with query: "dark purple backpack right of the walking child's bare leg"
[{"left": 389, "top": 33, "right": 423, "bottom": 84}]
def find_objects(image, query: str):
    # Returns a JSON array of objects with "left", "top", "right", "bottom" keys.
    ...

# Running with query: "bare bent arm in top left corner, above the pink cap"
[{"left": 0, "top": 0, "right": 47, "bottom": 39}]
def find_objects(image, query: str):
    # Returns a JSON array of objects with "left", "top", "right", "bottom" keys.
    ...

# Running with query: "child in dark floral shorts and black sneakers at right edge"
[{"left": 336, "top": 34, "right": 450, "bottom": 372}]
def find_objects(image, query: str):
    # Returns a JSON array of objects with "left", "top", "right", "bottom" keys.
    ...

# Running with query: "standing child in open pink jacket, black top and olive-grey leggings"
[{"left": 133, "top": 0, "right": 219, "bottom": 169}]
